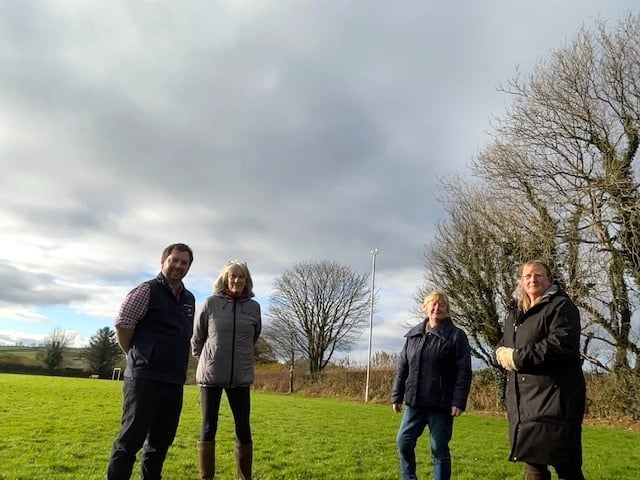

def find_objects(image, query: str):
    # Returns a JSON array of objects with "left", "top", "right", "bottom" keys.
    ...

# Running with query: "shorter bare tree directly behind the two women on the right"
[{"left": 416, "top": 178, "right": 551, "bottom": 367}]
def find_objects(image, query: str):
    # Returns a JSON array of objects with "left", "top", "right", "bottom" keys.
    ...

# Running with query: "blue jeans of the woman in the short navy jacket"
[{"left": 396, "top": 405, "right": 453, "bottom": 480}]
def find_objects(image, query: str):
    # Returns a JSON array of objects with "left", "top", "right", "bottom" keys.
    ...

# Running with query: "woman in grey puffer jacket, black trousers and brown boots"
[{"left": 191, "top": 261, "right": 262, "bottom": 480}]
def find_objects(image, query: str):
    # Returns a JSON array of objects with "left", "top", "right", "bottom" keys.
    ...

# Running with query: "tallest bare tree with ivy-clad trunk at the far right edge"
[{"left": 484, "top": 15, "right": 640, "bottom": 369}]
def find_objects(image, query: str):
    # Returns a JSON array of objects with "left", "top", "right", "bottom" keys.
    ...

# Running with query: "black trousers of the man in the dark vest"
[{"left": 107, "top": 378, "right": 184, "bottom": 480}]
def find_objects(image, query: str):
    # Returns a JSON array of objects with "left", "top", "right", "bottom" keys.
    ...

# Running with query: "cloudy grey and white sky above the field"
[{"left": 0, "top": 0, "right": 638, "bottom": 361}]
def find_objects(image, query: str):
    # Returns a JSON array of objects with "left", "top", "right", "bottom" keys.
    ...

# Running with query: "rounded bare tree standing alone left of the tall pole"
[{"left": 267, "top": 261, "right": 369, "bottom": 379}]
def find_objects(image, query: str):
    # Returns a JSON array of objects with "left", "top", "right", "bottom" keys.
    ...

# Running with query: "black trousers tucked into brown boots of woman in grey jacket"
[{"left": 200, "top": 387, "right": 251, "bottom": 443}]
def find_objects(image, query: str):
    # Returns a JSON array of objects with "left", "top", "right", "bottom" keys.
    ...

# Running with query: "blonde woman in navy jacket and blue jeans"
[{"left": 391, "top": 291, "right": 471, "bottom": 480}]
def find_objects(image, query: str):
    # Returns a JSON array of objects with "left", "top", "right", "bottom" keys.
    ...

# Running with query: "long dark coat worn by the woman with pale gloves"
[{"left": 501, "top": 288, "right": 586, "bottom": 465}]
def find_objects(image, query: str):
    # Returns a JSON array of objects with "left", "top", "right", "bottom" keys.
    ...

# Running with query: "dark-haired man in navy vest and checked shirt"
[{"left": 107, "top": 243, "right": 195, "bottom": 480}]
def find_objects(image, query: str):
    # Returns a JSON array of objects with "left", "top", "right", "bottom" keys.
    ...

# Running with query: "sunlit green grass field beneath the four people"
[{"left": 0, "top": 374, "right": 640, "bottom": 480}]
